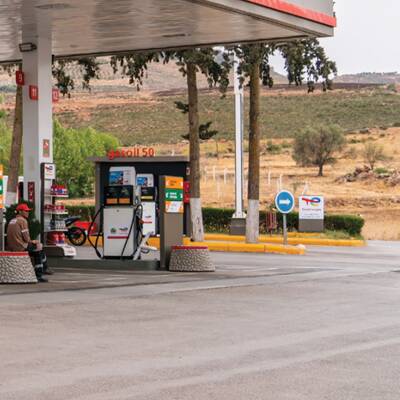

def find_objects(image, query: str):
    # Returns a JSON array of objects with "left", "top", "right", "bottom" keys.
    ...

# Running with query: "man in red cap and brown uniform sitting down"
[{"left": 7, "top": 204, "right": 52, "bottom": 282}]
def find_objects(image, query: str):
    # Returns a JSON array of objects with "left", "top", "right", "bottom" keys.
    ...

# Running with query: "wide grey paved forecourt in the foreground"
[{"left": 0, "top": 242, "right": 400, "bottom": 400}]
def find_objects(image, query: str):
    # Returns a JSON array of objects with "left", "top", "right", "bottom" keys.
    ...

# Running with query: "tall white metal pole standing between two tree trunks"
[{"left": 233, "top": 55, "right": 246, "bottom": 218}]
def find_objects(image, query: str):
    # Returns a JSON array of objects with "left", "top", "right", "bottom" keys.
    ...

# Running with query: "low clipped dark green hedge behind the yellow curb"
[{"left": 67, "top": 205, "right": 365, "bottom": 236}]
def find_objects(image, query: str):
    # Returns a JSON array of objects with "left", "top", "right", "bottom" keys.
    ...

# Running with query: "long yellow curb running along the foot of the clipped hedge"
[{"left": 205, "top": 233, "right": 365, "bottom": 247}]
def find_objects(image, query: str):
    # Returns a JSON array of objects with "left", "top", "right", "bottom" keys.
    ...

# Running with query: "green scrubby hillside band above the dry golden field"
[{"left": 49, "top": 89, "right": 400, "bottom": 145}]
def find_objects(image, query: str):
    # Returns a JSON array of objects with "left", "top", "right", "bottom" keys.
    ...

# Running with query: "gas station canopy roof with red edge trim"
[{"left": 0, "top": 0, "right": 336, "bottom": 62}]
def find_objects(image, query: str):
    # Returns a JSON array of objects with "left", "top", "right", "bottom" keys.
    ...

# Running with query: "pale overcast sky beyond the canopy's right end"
[{"left": 273, "top": 0, "right": 400, "bottom": 75}]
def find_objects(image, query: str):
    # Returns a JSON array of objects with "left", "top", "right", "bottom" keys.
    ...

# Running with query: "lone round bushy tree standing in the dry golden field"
[{"left": 292, "top": 125, "right": 346, "bottom": 176}]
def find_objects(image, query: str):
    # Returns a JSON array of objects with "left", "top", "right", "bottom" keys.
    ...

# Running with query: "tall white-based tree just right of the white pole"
[{"left": 234, "top": 39, "right": 336, "bottom": 243}]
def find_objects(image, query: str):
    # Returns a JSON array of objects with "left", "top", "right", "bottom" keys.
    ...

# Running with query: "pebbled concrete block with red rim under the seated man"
[{"left": 0, "top": 251, "right": 37, "bottom": 283}]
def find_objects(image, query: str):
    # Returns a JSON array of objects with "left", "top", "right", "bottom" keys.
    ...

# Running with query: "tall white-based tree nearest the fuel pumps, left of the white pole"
[{"left": 163, "top": 48, "right": 231, "bottom": 241}]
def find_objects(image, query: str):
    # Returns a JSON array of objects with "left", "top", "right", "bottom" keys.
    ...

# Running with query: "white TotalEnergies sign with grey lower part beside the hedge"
[{"left": 299, "top": 196, "right": 325, "bottom": 232}]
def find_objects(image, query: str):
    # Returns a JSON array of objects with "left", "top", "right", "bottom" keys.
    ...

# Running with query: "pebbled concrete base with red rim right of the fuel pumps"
[{"left": 169, "top": 246, "right": 215, "bottom": 272}]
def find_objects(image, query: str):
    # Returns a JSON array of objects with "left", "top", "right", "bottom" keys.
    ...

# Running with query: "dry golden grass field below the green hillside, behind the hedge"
[{"left": 148, "top": 128, "right": 400, "bottom": 240}]
